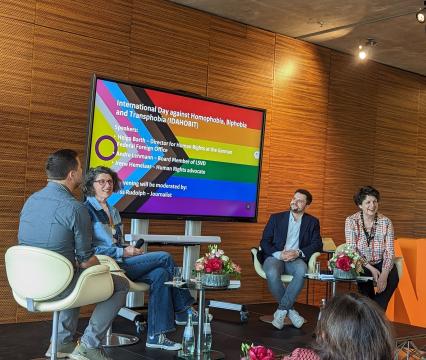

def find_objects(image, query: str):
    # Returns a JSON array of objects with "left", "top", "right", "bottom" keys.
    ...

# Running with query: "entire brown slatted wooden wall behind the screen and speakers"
[{"left": 0, "top": 0, "right": 426, "bottom": 323}]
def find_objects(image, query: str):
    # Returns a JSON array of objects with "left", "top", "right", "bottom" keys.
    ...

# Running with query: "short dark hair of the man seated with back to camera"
[{"left": 46, "top": 149, "right": 78, "bottom": 180}]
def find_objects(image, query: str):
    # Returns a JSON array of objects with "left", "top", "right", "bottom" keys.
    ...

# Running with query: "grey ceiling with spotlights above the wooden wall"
[{"left": 172, "top": 0, "right": 426, "bottom": 75}]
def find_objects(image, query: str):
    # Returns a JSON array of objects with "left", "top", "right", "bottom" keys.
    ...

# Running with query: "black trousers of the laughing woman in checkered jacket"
[{"left": 358, "top": 261, "right": 399, "bottom": 311}]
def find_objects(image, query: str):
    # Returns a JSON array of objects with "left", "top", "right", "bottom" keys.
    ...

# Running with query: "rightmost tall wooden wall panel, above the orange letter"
[{"left": 374, "top": 67, "right": 420, "bottom": 237}]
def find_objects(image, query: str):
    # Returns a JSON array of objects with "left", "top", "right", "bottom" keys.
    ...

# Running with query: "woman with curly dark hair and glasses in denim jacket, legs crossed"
[{"left": 83, "top": 166, "right": 198, "bottom": 350}]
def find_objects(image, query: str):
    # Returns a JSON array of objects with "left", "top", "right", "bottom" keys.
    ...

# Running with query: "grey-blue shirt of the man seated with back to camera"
[{"left": 18, "top": 182, "right": 94, "bottom": 264}]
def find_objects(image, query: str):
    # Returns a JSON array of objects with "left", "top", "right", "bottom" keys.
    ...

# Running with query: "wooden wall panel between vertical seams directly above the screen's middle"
[{"left": 130, "top": 0, "right": 209, "bottom": 95}]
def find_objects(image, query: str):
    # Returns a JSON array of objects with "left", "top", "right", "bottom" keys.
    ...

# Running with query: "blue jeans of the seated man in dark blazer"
[{"left": 263, "top": 256, "right": 308, "bottom": 310}]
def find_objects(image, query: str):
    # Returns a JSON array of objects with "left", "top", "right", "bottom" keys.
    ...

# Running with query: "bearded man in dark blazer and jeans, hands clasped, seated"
[{"left": 258, "top": 189, "right": 322, "bottom": 329}]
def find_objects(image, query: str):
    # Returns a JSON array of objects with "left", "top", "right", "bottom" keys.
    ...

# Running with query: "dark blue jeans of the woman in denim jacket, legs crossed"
[{"left": 120, "top": 251, "right": 194, "bottom": 336}]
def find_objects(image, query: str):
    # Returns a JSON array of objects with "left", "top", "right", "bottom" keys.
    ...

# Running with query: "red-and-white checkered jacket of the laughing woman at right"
[{"left": 345, "top": 211, "right": 395, "bottom": 271}]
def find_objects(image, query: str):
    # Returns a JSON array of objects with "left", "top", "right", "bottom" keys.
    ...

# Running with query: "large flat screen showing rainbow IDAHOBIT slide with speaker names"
[{"left": 86, "top": 76, "right": 265, "bottom": 221}]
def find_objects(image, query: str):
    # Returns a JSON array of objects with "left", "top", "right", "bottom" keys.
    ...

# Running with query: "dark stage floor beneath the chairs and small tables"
[{"left": 0, "top": 304, "right": 426, "bottom": 360}]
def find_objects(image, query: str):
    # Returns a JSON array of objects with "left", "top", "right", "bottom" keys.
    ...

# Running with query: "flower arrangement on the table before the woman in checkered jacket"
[{"left": 328, "top": 244, "right": 363, "bottom": 279}]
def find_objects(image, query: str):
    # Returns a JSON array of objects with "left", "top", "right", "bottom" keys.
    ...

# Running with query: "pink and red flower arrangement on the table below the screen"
[{"left": 195, "top": 245, "right": 241, "bottom": 287}]
